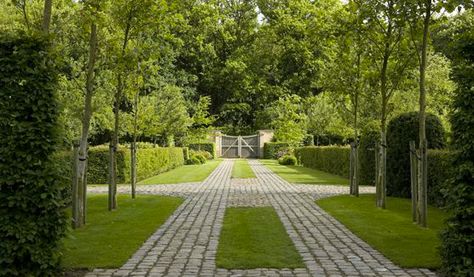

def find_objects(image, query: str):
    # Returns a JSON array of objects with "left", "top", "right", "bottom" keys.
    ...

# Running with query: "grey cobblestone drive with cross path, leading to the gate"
[{"left": 86, "top": 160, "right": 435, "bottom": 277}]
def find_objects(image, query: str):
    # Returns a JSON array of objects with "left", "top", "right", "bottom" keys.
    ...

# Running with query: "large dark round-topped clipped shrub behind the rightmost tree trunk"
[{"left": 387, "top": 112, "right": 446, "bottom": 197}]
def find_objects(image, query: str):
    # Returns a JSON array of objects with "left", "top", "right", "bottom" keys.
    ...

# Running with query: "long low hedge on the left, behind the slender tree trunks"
[{"left": 55, "top": 145, "right": 184, "bottom": 184}]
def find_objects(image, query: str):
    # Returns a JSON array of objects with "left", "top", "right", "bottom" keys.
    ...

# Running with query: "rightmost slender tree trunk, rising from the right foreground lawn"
[{"left": 418, "top": 0, "right": 431, "bottom": 227}]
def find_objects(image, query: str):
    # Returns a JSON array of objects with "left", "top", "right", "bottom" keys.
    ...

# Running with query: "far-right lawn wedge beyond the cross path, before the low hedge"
[{"left": 260, "top": 160, "right": 349, "bottom": 185}]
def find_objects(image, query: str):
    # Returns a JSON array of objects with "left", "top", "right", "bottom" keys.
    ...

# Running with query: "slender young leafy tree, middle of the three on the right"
[{"left": 358, "top": 0, "right": 411, "bottom": 208}]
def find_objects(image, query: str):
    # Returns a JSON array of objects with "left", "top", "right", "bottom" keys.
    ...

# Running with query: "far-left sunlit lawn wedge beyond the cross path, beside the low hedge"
[{"left": 138, "top": 160, "right": 221, "bottom": 185}]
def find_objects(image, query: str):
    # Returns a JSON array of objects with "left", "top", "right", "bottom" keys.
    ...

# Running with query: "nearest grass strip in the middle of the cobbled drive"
[{"left": 216, "top": 207, "right": 305, "bottom": 269}]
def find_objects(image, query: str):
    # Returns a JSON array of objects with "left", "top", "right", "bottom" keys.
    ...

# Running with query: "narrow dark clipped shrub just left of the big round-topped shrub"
[{"left": 358, "top": 129, "right": 380, "bottom": 186}]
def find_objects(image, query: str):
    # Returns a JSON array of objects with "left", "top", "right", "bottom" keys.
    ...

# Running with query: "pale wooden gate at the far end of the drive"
[{"left": 221, "top": 135, "right": 260, "bottom": 158}]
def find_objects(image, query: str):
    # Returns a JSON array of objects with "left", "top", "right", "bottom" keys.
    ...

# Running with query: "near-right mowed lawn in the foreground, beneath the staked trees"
[{"left": 316, "top": 194, "right": 447, "bottom": 269}]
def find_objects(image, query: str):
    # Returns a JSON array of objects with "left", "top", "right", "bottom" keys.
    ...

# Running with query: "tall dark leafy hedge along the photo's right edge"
[{"left": 439, "top": 10, "right": 474, "bottom": 277}]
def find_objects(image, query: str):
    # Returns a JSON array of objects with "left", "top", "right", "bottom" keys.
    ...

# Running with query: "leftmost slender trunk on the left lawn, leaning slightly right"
[{"left": 73, "top": 23, "right": 97, "bottom": 228}]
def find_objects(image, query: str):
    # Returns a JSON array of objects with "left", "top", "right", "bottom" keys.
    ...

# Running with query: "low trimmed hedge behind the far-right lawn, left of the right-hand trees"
[{"left": 295, "top": 146, "right": 351, "bottom": 178}]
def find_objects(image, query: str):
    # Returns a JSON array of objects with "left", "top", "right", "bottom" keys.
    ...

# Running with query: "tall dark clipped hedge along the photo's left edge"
[{"left": 0, "top": 33, "right": 68, "bottom": 276}]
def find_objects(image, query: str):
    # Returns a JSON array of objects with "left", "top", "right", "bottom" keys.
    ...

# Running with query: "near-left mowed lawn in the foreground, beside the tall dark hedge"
[{"left": 63, "top": 194, "right": 183, "bottom": 268}]
